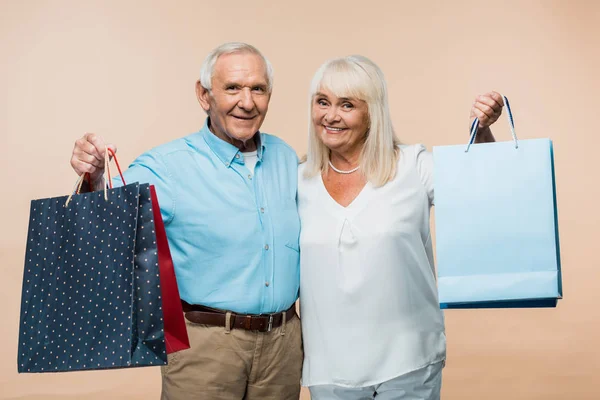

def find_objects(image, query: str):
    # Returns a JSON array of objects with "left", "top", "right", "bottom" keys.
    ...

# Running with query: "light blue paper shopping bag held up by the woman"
[{"left": 433, "top": 97, "right": 562, "bottom": 308}]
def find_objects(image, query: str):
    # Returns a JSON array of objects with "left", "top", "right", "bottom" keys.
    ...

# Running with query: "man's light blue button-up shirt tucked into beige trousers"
[{"left": 116, "top": 120, "right": 300, "bottom": 314}]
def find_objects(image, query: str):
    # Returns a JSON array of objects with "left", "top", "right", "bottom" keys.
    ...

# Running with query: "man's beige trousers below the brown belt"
[{"left": 161, "top": 310, "right": 304, "bottom": 400}]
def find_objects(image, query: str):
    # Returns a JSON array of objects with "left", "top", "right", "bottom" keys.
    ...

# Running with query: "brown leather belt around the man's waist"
[{"left": 181, "top": 300, "right": 296, "bottom": 332}]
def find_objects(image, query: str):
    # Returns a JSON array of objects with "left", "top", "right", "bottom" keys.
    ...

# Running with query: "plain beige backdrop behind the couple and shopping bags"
[{"left": 0, "top": 0, "right": 600, "bottom": 400}]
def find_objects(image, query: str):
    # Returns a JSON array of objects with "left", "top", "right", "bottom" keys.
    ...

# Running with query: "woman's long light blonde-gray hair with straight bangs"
[{"left": 304, "top": 56, "right": 400, "bottom": 187}]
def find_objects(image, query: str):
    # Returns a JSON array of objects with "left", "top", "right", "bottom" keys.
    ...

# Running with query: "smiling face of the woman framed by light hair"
[{"left": 312, "top": 89, "right": 369, "bottom": 154}]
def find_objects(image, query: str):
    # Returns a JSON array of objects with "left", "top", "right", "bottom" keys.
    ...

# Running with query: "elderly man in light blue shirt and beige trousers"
[{"left": 71, "top": 43, "right": 303, "bottom": 400}]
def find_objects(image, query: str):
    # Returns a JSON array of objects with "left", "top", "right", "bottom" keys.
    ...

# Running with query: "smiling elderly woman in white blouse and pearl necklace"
[{"left": 298, "top": 56, "right": 503, "bottom": 400}]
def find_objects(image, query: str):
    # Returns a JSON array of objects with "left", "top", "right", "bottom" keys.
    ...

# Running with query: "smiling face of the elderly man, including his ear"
[{"left": 196, "top": 52, "right": 271, "bottom": 148}]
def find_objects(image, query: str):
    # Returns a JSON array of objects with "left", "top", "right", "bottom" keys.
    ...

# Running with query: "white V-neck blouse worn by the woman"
[{"left": 298, "top": 145, "right": 446, "bottom": 387}]
